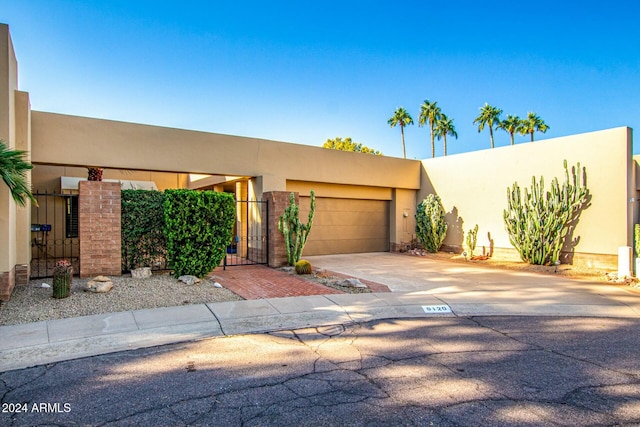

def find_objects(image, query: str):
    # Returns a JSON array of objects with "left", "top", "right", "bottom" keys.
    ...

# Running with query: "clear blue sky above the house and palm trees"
[{"left": 0, "top": 0, "right": 640, "bottom": 159}]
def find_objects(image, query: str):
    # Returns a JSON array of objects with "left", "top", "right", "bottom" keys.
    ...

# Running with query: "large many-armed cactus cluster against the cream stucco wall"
[{"left": 504, "top": 160, "right": 589, "bottom": 265}]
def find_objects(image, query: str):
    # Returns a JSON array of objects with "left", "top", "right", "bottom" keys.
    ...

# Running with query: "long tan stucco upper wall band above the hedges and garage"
[{"left": 32, "top": 111, "right": 420, "bottom": 191}]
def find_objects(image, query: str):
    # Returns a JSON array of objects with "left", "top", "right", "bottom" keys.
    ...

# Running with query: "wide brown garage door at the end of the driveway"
[{"left": 300, "top": 197, "right": 389, "bottom": 255}]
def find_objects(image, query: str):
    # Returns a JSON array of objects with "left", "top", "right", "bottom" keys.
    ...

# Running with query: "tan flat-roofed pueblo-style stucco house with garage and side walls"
[{"left": 0, "top": 25, "right": 638, "bottom": 300}]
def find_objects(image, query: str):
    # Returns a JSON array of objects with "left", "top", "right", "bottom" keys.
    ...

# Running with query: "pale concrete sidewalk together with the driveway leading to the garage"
[{"left": 0, "top": 253, "right": 640, "bottom": 372}]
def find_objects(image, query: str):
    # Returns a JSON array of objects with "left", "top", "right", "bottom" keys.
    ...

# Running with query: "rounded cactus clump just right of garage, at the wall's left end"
[{"left": 416, "top": 194, "right": 447, "bottom": 253}]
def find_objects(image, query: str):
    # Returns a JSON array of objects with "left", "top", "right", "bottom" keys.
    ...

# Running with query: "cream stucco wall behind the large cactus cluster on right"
[{"left": 418, "top": 127, "right": 635, "bottom": 254}]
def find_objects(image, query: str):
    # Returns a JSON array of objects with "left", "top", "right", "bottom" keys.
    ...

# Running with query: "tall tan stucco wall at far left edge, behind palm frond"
[{"left": 0, "top": 24, "right": 18, "bottom": 274}]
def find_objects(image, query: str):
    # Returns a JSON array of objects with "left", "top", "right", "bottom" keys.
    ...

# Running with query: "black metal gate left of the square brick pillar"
[{"left": 30, "top": 192, "right": 80, "bottom": 279}]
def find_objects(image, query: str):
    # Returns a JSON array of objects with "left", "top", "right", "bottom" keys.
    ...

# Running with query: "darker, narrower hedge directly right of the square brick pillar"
[{"left": 122, "top": 190, "right": 167, "bottom": 271}]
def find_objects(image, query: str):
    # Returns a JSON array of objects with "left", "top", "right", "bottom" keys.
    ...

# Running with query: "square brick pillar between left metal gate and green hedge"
[{"left": 78, "top": 181, "right": 122, "bottom": 277}]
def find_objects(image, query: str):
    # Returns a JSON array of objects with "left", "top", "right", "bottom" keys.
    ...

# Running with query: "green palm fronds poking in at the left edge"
[{"left": 0, "top": 140, "right": 38, "bottom": 206}]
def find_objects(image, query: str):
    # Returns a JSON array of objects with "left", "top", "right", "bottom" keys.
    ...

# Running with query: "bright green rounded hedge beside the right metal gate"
[{"left": 164, "top": 190, "right": 236, "bottom": 277}]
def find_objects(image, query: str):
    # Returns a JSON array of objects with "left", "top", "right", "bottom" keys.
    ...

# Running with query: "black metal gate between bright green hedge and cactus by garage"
[{"left": 223, "top": 200, "right": 269, "bottom": 268}]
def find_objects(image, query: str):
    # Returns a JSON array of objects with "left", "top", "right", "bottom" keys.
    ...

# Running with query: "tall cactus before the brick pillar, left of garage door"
[{"left": 278, "top": 190, "right": 316, "bottom": 265}]
